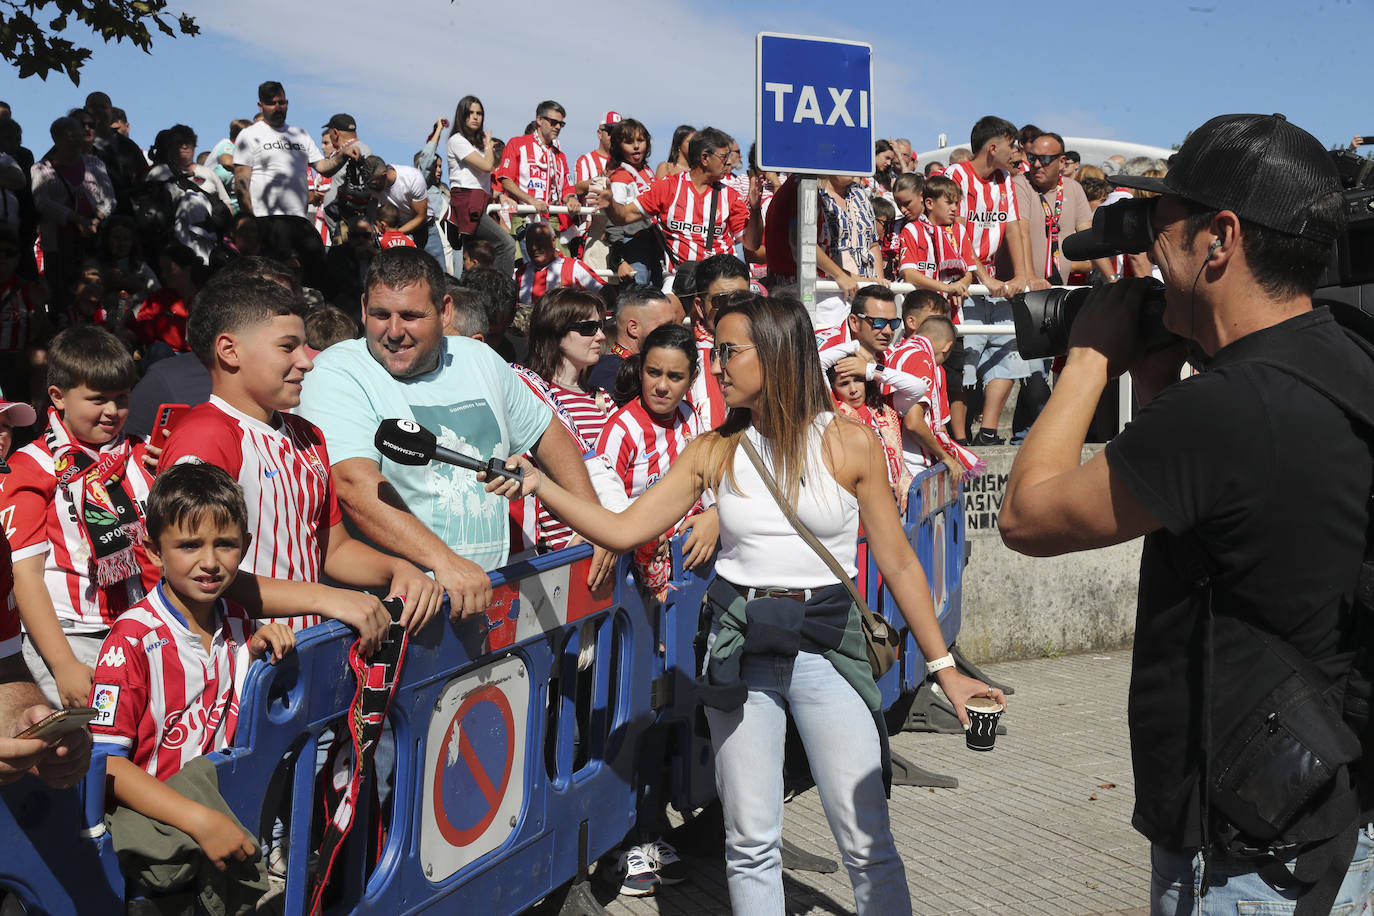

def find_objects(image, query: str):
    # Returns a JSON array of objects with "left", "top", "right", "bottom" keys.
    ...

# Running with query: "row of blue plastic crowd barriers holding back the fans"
[{"left": 0, "top": 466, "right": 965, "bottom": 916}]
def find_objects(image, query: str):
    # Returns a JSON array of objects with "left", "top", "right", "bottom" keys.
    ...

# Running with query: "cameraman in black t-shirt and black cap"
[{"left": 999, "top": 115, "right": 1374, "bottom": 913}]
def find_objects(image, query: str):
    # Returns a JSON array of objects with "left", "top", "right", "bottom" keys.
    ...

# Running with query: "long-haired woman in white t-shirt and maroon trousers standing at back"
[{"left": 448, "top": 95, "right": 515, "bottom": 276}]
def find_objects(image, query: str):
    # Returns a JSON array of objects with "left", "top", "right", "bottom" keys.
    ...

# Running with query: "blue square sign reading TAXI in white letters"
[{"left": 754, "top": 32, "right": 874, "bottom": 174}]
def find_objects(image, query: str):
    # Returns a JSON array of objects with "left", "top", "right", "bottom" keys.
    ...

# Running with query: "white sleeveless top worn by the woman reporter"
[{"left": 716, "top": 413, "right": 859, "bottom": 589}]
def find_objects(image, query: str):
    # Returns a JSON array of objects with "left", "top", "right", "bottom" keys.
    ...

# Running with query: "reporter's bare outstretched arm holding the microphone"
[{"left": 486, "top": 434, "right": 713, "bottom": 553}]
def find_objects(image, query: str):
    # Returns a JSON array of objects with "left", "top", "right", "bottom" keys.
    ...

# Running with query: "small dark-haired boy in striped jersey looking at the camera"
[{"left": 91, "top": 464, "right": 295, "bottom": 912}]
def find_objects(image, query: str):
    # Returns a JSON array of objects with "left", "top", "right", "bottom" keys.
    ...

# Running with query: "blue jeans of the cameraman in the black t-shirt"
[{"left": 1150, "top": 825, "right": 1374, "bottom": 916}]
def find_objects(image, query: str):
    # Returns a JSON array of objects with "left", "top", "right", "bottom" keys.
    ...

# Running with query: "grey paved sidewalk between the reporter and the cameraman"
[{"left": 598, "top": 651, "right": 1150, "bottom": 916}]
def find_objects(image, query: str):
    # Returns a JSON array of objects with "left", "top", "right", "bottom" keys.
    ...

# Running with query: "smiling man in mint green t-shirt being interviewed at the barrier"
[{"left": 298, "top": 247, "right": 596, "bottom": 619}]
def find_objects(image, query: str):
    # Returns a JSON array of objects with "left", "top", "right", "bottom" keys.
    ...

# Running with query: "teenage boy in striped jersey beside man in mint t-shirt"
[{"left": 159, "top": 271, "right": 442, "bottom": 632}]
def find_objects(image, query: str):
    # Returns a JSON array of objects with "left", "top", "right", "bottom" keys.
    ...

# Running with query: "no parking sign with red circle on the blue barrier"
[{"left": 420, "top": 656, "right": 530, "bottom": 883}]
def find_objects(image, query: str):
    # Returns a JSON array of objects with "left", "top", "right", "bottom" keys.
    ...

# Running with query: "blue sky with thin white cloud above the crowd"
[{"left": 0, "top": 0, "right": 1374, "bottom": 170}]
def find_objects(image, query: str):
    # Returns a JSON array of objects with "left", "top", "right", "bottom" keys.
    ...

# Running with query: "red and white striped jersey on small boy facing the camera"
[{"left": 91, "top": 585, "right": 253, "bottom": 780}]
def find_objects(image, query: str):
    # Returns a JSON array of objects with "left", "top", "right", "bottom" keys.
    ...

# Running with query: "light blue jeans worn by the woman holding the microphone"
[{"left": 706, "top": 652, "right": 911, "bottom": 916}]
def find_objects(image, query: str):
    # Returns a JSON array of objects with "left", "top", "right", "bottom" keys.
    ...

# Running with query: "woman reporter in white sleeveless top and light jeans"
[{"left": 488, "top": 295, "right": 1003, "bottom": 915}]
